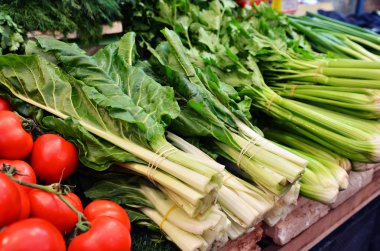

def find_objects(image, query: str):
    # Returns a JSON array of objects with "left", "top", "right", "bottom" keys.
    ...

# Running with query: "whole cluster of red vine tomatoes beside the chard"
[{"left": 0, "top": 97, "right": 131, "bottom": 251}]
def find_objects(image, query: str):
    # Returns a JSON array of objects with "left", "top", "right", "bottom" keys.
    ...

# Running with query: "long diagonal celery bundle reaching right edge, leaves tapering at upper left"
[{"left": 241, "top": 86, "right": 380, "bottom": 162}]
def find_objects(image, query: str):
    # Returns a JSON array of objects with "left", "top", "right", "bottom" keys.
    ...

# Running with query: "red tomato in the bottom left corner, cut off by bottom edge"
[{"left": 0, "top": 219, "right": 66, "bottom": 251}]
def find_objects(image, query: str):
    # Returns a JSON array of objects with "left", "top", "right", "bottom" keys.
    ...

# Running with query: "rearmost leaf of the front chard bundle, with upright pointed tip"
[{"left": 94, "top": 32, "right": 180, "bottom": 127}]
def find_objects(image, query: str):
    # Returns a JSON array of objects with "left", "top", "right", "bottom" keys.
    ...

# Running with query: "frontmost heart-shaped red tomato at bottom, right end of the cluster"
[{"left": 68, "top": 216, "right": 131, "bottom": 251}]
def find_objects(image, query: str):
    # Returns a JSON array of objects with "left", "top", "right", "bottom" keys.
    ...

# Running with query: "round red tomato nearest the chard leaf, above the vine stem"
[{"left": 30, "top": 134, "right": 79, "bottom": 184}]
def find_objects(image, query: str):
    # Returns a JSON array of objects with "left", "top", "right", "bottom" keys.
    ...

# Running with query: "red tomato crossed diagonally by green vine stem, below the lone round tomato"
[{"left": 29, "top": 189, "right": 83, "bottom": 234}]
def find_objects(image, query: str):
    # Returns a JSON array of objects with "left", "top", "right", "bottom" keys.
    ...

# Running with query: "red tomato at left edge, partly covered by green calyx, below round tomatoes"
[{"left": 0, "top": 160, "right": 37, "bottom": 192}]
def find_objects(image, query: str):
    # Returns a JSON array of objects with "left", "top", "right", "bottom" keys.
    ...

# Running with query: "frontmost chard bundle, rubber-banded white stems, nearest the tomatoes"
[{"left": 0, "top": 32, "right": 223, "bottom": 219}]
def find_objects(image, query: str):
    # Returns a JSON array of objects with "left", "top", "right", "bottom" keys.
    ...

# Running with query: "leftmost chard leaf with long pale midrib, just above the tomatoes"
[{"left": 0, "top": 54, "right": 150, "bottom": 162}]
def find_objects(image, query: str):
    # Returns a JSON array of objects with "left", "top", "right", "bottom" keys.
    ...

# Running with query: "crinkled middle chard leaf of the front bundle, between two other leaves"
[{"left": 31, "top": 37, "right": 164, "bottom": 143}]
